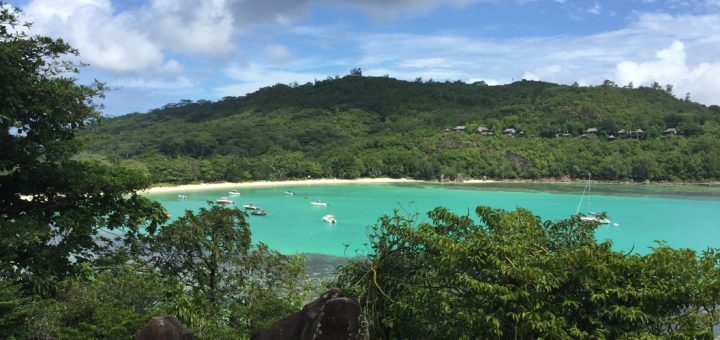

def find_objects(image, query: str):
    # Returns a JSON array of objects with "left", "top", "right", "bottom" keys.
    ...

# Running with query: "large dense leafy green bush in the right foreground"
[{"left": 338, "top": 206, "right": 720, "bottom": 339}]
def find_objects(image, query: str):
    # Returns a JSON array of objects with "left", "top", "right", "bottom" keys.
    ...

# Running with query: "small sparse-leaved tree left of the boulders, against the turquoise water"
[{"left": 148, "top": 205, "right": 304, "bottom": 329}]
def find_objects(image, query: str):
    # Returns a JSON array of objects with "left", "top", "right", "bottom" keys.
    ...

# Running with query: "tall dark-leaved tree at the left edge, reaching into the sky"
[{"left": 0, "top": 6, "right": 165, "bottom": 291}]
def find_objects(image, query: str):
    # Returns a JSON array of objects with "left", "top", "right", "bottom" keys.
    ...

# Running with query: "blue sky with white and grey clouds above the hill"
[{"left": 6, "top": 0, "right": 720, "bottom": 115}]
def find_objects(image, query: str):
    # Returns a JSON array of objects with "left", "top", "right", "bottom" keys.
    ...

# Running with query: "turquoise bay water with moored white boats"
[{"left": 148, "top": 183, "right": 720, "bottom": 256}]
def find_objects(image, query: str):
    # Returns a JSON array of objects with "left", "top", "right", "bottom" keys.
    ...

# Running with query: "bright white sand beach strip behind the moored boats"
[{"left": 141, "top": 178, "right": 442, "bottom": 194}]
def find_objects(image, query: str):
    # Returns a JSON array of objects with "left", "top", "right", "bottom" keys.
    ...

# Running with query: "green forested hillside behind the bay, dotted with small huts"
[{"left": 84, "top": 74, "right": 720, "bottom": 183}]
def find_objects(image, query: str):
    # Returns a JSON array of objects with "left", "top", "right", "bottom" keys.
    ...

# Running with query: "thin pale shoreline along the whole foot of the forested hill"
[{"left": 138, "top": 177, "right": 720, "bottom": 195}]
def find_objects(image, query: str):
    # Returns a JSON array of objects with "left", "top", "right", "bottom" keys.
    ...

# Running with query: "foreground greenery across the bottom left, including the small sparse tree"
[{"left": 0, "top": 206, "right": 320, "bottom": 339}]
